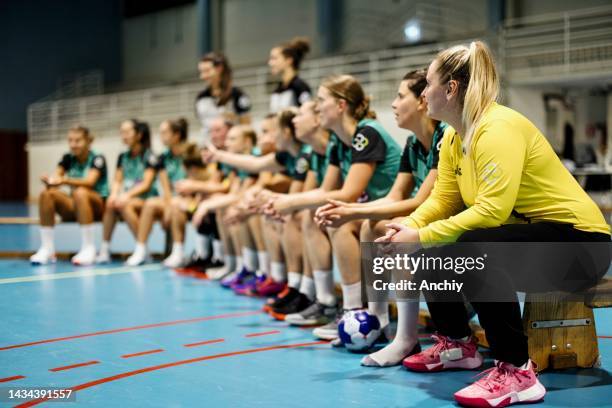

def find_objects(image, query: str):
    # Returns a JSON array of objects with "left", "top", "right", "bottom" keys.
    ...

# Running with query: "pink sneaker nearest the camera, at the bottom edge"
[{"left": 455, "top": 360, "right": 546, "bottom": 407}]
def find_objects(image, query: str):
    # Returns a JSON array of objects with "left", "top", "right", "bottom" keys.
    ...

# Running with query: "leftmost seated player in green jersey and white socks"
[{"left": 30, "top": 126, "right": 108, "bottom": 265}]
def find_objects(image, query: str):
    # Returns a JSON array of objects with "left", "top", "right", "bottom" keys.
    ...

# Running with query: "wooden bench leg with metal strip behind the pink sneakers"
[{"left": 523, "top": 294, "right": 599, "bottom": 371}]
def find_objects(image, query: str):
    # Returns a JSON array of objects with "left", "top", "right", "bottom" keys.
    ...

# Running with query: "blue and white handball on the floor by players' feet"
[{"left": 338, "top": 310, "right": 381, "bottom": 351}]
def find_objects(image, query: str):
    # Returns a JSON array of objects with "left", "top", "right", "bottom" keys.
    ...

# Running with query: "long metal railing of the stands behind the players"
[{"left": 28, "top": 6, "right": 612, "bottom": 143}]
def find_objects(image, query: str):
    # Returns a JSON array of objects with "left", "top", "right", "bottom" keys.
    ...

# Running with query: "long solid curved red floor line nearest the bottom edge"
[{"left": 15, "top": 341, "right": 329, "bottom": 408}]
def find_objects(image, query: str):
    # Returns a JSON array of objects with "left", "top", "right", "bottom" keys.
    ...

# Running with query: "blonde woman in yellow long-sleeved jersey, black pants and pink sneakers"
[{"left": 380, "top": 42, "right": 610, "bottom": 406}]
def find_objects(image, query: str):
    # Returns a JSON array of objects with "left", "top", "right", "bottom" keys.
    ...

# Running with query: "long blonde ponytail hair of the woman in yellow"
[{"left": 435, "top": 41, "right": 499, "bottom": 154}]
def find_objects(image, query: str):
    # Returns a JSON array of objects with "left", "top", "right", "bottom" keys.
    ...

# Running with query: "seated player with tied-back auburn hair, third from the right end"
[{"left": 273, "top": 75, "right": 401, "bottom": 340}]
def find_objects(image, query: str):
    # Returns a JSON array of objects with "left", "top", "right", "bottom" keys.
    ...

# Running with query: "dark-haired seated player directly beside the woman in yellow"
[{"left": 304, "top": 70, "right": 447, "bottom": 367}]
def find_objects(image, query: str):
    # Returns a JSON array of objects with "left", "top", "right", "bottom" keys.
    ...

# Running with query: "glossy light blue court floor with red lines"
[{"left": 0, "top": 260, "right": 612, "bottom": 407}]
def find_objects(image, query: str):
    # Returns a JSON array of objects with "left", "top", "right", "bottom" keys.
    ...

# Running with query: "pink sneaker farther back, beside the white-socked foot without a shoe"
[{"left": 403, "top": 334, "right": 482, "bottom": 371}]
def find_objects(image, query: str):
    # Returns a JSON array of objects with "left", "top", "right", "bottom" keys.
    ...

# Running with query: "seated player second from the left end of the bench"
[{"left": 96, "top": 119, "right": 157, "bottom": 263}]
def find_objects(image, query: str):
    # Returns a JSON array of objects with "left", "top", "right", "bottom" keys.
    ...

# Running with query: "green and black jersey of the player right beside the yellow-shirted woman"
[{"left": 399, "top": 122, "right": 448, "bottom": 197}]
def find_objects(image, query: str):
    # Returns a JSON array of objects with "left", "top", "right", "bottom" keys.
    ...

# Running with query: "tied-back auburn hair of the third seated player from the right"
[{"left": 321, "top": 75, "right": 376, "bottom": 121}]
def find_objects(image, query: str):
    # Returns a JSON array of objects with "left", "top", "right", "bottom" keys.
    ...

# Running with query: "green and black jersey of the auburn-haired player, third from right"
[{"left": 329, "top": 119, "right": 402, "bottom": 202}]
